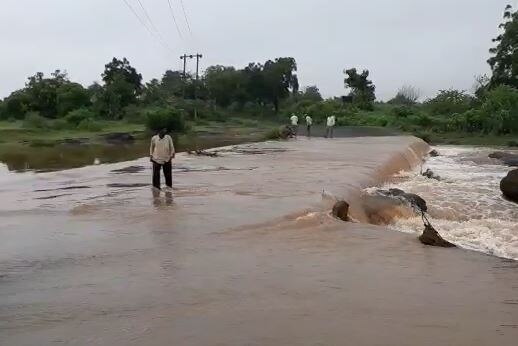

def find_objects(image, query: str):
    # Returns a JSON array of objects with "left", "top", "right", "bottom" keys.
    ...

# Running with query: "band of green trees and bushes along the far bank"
[{"left": 0, "top": 7, "right": 518, "bottom": 145}]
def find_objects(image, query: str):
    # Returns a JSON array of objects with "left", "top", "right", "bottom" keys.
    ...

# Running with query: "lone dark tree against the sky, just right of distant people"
[{"left": 344, "top": 68, "right": 376, "bottom": 110}]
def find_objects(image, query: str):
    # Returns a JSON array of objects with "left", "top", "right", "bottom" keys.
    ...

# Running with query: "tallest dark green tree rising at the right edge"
[{"left": 488, "top": 5, "right": 518, "bottom": 88}]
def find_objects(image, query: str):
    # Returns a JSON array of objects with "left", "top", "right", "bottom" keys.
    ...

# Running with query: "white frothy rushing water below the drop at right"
[{"left": 387, "top": 146, "right": 518, "bottom": 260}]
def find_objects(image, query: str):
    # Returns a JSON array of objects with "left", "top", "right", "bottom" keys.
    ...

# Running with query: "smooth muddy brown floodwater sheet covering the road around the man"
[{"left": 0, "top": 137, "right": 518, "bottom": 346}]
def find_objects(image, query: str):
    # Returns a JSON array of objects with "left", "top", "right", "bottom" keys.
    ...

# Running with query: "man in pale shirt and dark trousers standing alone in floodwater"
[{"left": 149, "top": 129, "right": 176, "bottom": 190}]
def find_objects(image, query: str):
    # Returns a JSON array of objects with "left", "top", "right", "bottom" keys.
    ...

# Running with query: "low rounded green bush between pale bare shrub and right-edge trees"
[{"left": 425, "top": 89, "right": 473, "bottom": 116}]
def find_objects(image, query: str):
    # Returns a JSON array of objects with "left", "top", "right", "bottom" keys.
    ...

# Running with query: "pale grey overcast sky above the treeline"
[{"left": 0, "top": 0, "right": 518, "bottom": 99}]
